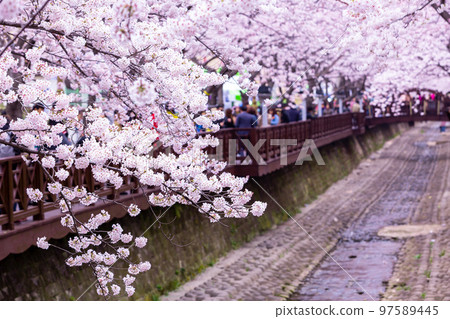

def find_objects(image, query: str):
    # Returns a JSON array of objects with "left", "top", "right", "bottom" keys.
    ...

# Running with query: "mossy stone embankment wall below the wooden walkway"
[{"left": 0, "top": 125, "right": 406, "bottom": 300}]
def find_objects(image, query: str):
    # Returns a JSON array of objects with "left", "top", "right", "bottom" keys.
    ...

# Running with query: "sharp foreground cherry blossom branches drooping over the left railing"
[{"left": 0, "top": 0, "right": 266, "bottom": 296}]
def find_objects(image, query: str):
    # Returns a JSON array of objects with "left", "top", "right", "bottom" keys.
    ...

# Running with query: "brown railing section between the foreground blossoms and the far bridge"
[{"left": 208, "top": 113, "right": 356, "bottom": 176}]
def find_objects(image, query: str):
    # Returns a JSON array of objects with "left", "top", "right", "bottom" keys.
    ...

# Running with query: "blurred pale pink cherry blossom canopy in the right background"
[{"left": 191, "top": 0, "right": 449, "bottom": 109}]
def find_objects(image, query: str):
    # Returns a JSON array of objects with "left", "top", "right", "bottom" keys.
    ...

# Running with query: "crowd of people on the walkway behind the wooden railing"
[{"left": 0, "top": 93, "right": 450, "bottom": 158}]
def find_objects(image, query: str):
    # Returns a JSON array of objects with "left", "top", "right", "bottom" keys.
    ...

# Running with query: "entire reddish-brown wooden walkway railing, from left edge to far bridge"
[{"left": 0, "top": 113, "right": 448, "bottom": 260}]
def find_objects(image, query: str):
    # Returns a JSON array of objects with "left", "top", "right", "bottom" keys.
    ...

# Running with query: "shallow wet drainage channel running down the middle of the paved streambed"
[{"left": 289, "top": 136, "right": 436, "bottom": 301}]
